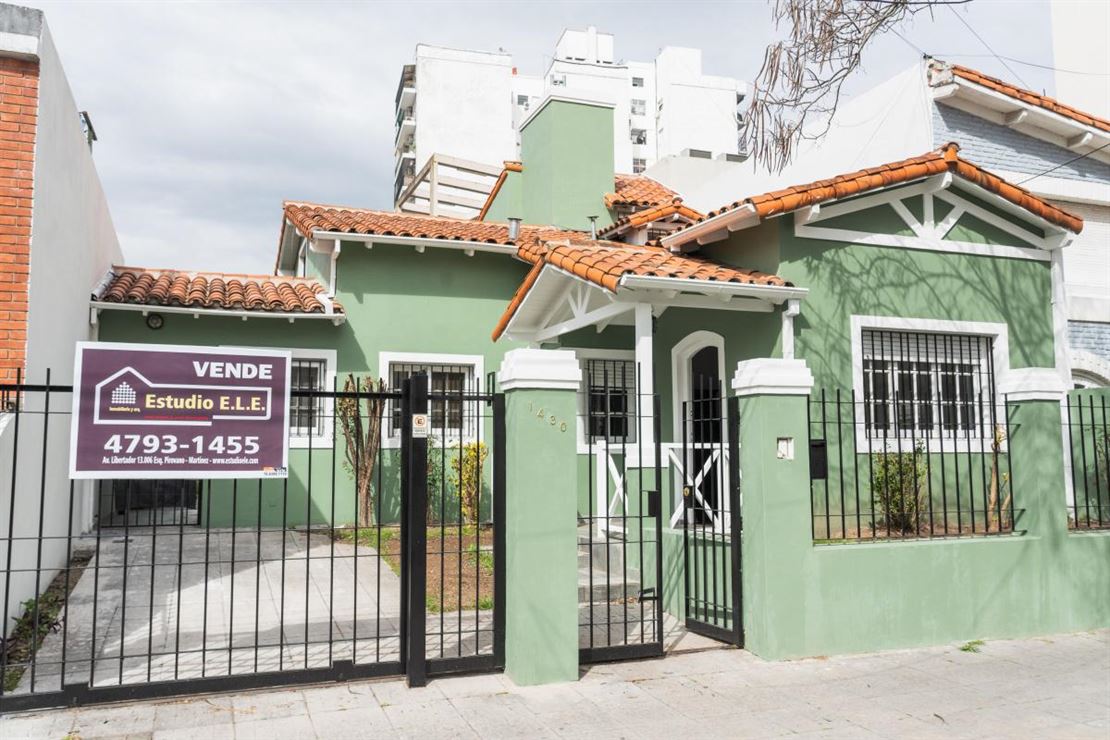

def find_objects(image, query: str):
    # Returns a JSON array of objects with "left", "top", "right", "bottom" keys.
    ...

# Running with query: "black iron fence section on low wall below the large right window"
[{"left": 809, "top": 389, "right": 1021, "bottom": 543}]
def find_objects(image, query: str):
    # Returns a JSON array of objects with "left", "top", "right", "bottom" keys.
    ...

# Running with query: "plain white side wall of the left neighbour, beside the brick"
[{"left": 0, "top": 24, "right": 121, "bottom": 639}]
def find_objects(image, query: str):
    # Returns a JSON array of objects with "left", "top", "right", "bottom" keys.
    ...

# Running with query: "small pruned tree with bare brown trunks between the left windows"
[{"left": 335, "top": 374, "right": 385, "bottom": 527}]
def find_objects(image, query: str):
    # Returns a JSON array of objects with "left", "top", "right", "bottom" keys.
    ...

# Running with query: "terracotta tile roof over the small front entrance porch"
[{"left": 493, "top": 240, "right": 791, "bottom": 341}]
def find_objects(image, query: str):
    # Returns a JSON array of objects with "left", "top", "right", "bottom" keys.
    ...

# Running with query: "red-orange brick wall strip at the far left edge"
[{"left": 0, "top": 58, "right": 39, "bottom": 383}]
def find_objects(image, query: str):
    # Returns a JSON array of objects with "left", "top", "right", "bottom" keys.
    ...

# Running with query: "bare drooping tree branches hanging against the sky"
[{"left": 744, "top": 0, "right": 950, "bottom": 172}]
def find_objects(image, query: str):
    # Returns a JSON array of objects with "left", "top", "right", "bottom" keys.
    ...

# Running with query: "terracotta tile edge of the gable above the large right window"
[{"left": 663, "top": 143, "right": 1083, "bottom": 246}]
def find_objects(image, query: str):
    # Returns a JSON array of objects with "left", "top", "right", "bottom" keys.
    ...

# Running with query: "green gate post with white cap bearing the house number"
[{"left": 497, "top": 349, "right": 582, "bottom": 686}]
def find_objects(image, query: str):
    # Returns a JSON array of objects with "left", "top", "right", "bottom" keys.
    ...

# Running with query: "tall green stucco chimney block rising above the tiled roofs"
[{"left": 521, "top": 100, "right": 613, "bottom": 230}]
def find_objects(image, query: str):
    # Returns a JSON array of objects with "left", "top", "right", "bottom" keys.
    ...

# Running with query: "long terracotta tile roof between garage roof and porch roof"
[{"left": 284, "top": 201, "right": 583, "bottom": 246}]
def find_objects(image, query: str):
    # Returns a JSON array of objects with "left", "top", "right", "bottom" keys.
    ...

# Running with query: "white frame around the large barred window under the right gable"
[{"left": 843, "top": 315, "right": 1010, "bottom": 453}]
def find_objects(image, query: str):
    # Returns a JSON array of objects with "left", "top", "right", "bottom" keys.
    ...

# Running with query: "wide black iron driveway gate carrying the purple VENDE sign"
[{"left": 0, "top": 374, "right": 505, "bottom": 711}]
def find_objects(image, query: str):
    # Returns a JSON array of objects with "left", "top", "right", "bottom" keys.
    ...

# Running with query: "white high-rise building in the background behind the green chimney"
[{"left": 394, "top": 27, "right": 746, "bottom": 216}]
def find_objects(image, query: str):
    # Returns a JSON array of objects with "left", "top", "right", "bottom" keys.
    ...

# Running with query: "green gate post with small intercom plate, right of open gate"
[{"left": 733, "top": 358, "right": 814, "bottom": 659}]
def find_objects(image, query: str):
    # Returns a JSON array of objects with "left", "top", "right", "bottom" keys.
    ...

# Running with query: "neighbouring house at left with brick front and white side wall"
[{"left": 0, "top": 4, "right": 120, "bottom": 639}]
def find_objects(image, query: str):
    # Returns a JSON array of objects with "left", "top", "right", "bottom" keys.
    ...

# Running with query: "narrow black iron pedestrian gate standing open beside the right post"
[{"left": 682, "top": 390, "right": 744, "bottom": 646}]
